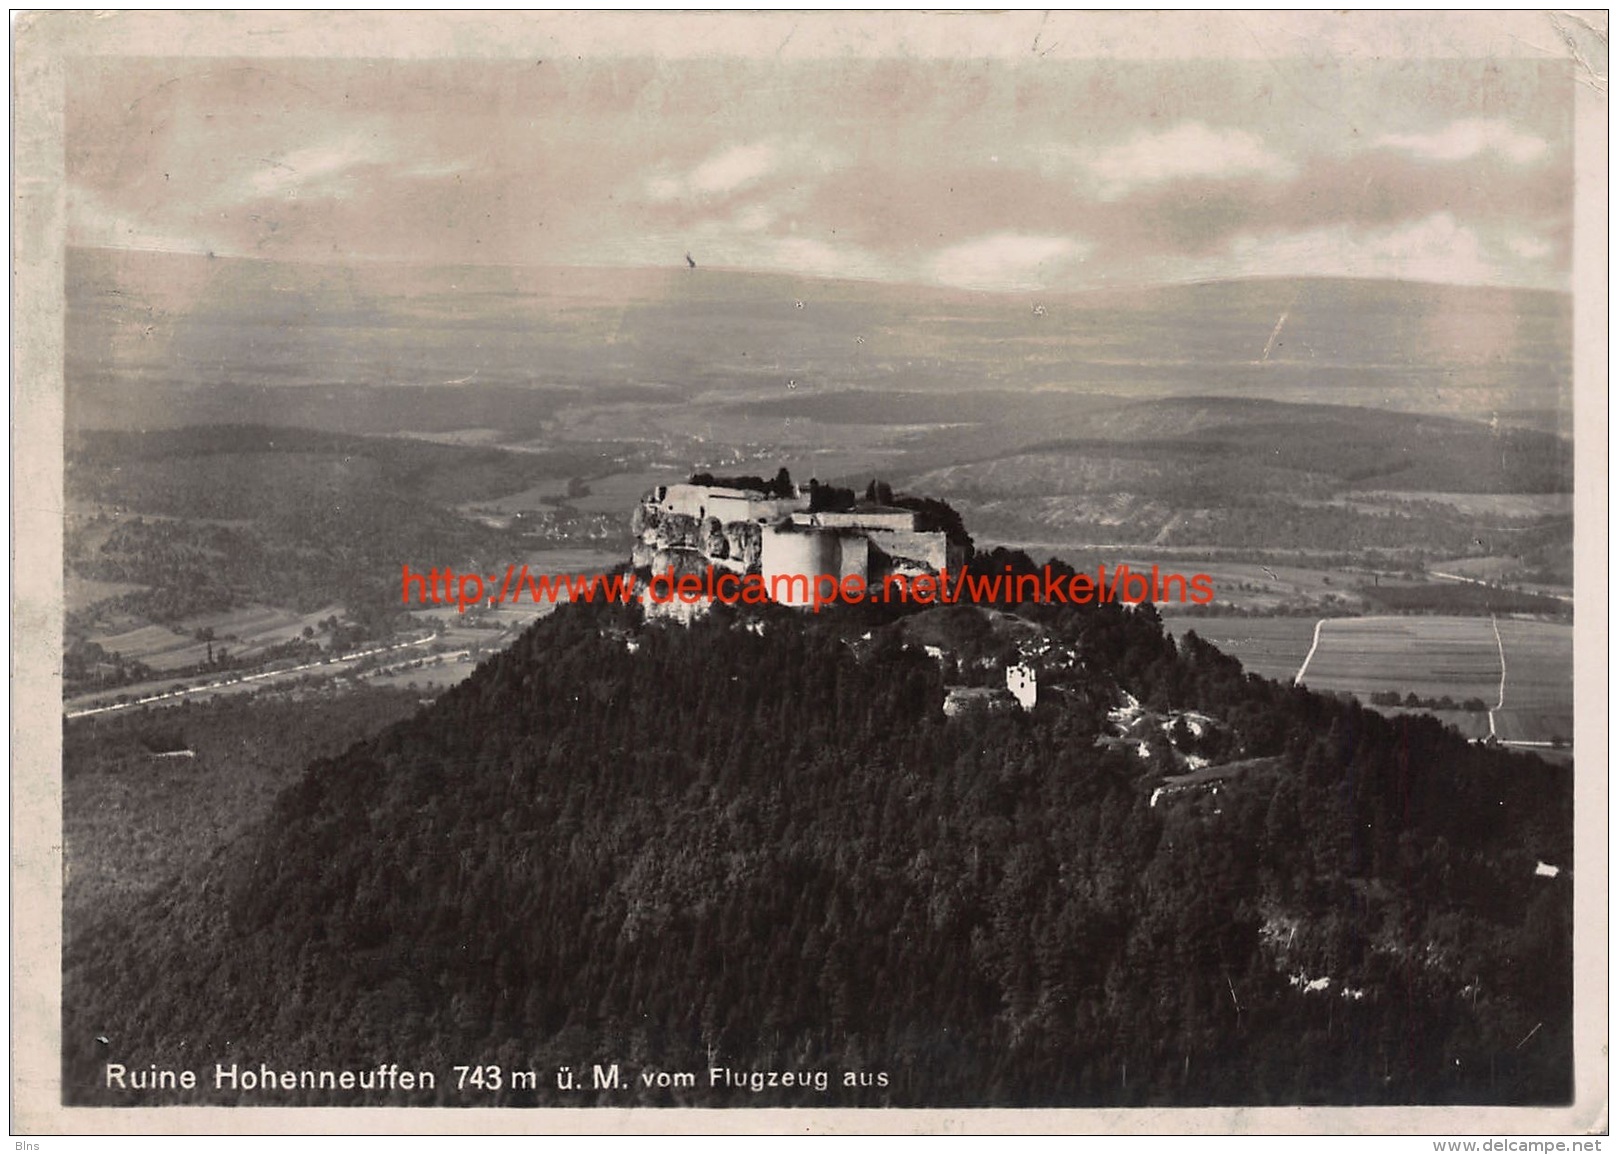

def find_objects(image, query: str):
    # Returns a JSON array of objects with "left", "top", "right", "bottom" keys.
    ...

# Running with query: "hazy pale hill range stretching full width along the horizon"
[{"left": 66, "top": 249, "right": 1571, "bottom": 432}]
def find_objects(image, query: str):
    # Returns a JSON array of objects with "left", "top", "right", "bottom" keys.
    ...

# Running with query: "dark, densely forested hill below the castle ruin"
[{"left": 63, "top": 560, "right": 1573, "bottom": 1106}]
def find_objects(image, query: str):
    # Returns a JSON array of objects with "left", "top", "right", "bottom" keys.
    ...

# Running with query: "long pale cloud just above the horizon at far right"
[{"left": 1196, "top": 212, "right": 1550, "bottom": 285}]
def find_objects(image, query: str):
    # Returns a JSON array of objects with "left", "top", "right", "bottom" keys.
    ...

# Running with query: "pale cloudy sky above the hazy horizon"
[{"left": 65, "top": 33, "right": 1573, "bottom": 293}]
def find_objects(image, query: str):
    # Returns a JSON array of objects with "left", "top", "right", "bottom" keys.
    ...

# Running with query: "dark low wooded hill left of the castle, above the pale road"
[{"left": 65, "top": 425, "right": 594, "bottom": 629}]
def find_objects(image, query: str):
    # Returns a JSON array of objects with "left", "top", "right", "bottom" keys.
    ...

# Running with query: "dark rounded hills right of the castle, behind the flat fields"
[{"left": 815, "top": 391, "right": 1573, "bottom": 559}]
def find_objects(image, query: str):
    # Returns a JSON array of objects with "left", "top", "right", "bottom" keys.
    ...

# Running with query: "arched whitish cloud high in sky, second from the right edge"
[{"left": 1069, "top": 121, "right": 1298, "bottom": 201}]
